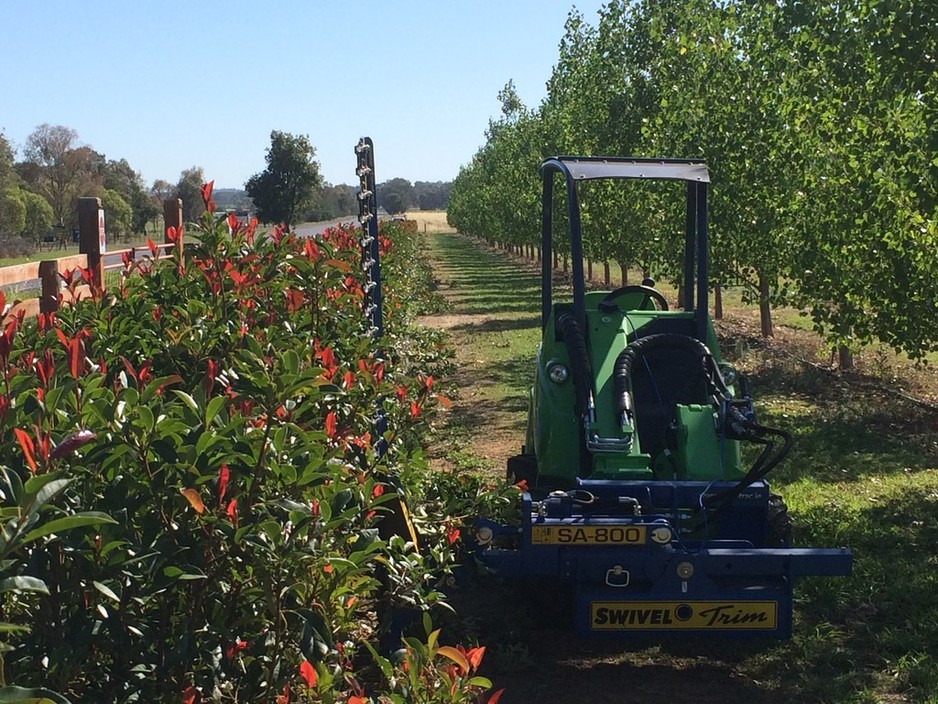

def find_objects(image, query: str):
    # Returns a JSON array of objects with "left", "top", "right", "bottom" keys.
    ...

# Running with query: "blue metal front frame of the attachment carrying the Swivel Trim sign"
[{"left": 475, "top": 480, "right": 852, "bottom": 638}]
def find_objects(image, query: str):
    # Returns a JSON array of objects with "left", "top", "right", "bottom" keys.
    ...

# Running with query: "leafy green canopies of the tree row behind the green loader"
[{"left": 448, "top": 0, "right": 938, "bottom": 358}]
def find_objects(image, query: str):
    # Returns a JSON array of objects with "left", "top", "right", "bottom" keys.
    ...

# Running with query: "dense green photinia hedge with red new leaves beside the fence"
[{"left": 0, "top": 186, "right": 481, "bottom": 703}]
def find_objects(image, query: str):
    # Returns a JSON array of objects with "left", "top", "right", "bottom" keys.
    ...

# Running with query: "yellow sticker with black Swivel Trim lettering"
[{"left": 590, "top": 600, "right": 778, "bottom": 631}]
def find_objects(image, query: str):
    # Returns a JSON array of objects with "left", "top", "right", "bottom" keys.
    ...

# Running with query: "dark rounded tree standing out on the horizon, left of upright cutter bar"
[{"left": 244, "top": 130, "right": 322, "bottom": 227}]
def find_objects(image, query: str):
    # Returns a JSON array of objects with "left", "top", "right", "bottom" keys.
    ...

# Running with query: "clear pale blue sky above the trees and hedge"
[{"left": 0, "top": 0, "right": 602, "bottom": 188}]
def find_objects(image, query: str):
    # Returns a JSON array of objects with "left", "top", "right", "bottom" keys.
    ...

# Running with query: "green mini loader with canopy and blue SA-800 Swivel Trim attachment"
[{"left": 474, "top": 157, "right": 852, "bottom": 638}]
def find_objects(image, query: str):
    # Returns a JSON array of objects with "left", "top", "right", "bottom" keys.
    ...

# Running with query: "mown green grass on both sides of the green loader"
[{"left": 422, "top": 228, "right": 938, "bottom": 704}]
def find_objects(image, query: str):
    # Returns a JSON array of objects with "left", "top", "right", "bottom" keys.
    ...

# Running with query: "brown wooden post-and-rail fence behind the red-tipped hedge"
[{"left": 0, "top": 198, "right": 182, "bottom": 322}]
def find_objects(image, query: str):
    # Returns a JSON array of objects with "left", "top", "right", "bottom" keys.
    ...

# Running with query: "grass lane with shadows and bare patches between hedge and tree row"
[{"left": 428, "top": 233, "right": 938, "bottom": 704}]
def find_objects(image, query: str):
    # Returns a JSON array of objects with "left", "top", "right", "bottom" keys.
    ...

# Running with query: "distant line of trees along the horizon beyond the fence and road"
[{"left": 0, "top": 124, "right": 452, "bottom": 256}]
